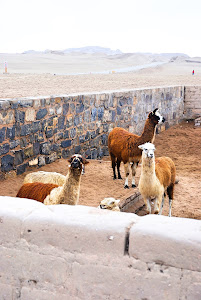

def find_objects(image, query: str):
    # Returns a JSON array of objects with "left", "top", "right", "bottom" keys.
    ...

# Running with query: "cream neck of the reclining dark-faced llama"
[{"left": 63, "top": 167, "right": 81, "bottom": 205}]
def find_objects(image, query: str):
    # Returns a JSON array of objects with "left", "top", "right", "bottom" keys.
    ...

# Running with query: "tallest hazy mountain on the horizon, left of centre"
[{"left": 63, "top": 46, "right": 123, "bottom": 55}]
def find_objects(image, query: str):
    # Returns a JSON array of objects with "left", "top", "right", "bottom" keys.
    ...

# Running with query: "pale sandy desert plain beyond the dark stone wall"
[{"left": 0, "top": 54, "right": 201, "bottom": 99}]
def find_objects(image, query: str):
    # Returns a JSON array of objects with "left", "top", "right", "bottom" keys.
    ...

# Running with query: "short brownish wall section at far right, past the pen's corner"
[{"left": 184, "top": 86, "right": 201, "bottom": 119}]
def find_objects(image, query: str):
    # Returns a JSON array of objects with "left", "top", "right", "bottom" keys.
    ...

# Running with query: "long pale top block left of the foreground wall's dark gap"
[{"left": 22, "top": 205, "right": 139, "bottom": 258}]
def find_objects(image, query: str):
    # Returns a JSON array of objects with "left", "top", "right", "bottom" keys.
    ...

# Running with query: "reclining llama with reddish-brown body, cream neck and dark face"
[{"left": 16, "top": 154, "right": 89, "bottom": 205}]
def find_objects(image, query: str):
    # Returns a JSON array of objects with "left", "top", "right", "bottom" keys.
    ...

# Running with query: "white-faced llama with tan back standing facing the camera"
[{"left": 138, "top": 143, "right": 176, "bottom": 217}]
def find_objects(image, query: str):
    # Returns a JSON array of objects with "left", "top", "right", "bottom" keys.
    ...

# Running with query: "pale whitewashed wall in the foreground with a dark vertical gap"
[{"left": 0, "top": 197, "right": 201, "bottom": 300}]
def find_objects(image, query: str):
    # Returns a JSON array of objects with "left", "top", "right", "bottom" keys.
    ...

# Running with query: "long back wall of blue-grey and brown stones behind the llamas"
[{"left": 0, "top": 86, "right": 184, "bottom": 179}]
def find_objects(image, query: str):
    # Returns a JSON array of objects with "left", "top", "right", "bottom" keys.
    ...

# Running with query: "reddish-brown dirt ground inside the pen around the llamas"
[{"left": 0, "top": 122, "right": 201, "bottom": 219}]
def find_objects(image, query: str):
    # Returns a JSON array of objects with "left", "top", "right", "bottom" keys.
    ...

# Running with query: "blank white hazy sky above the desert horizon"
[{"left": 0, "top": 0, "right": 201, "bottom": 56}]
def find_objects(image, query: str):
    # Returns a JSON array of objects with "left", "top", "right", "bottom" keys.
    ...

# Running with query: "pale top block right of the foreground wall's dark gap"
[{"left": 129, "top": 215, "right": 201, "bottom": 272}]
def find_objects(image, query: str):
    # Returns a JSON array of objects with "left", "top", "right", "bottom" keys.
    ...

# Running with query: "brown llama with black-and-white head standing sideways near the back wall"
[{"left": 108, "top": 108, "right": 165, "bottom": 188}]
